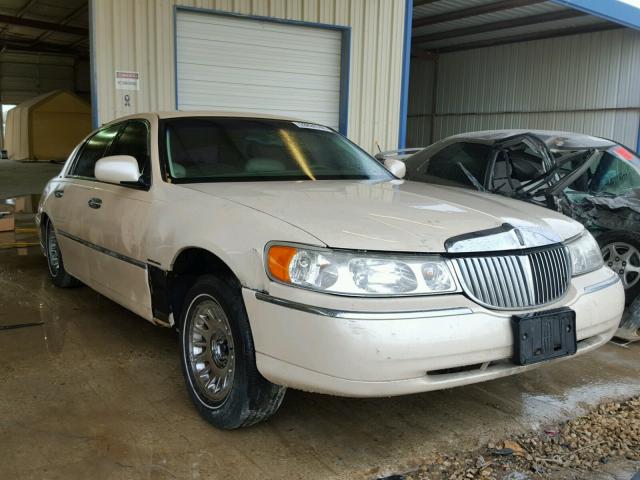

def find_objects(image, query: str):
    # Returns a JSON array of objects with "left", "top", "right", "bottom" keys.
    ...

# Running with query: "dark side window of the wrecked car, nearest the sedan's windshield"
[{"left": 405, "top": 142, "right": 491, "bottom": 188}]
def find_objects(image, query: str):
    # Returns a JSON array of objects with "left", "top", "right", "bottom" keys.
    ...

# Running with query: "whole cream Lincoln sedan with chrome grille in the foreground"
[{"left": 37, "top": 112, "right": 624, "bottom": 428}]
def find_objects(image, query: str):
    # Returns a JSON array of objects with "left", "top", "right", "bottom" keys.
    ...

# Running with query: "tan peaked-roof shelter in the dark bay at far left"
[{"left": 5, "top": 90, "right": 91, "bottom": 160}]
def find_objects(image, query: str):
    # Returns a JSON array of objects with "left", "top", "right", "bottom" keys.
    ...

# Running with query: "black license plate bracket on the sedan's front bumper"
[{"left": 511, "top": 307, "right": 578, "bottom": 365}]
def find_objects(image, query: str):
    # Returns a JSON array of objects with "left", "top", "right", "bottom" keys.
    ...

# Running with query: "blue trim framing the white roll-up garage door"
[{"left": 173, "top": 5, "right": 350, "bottom": 135}]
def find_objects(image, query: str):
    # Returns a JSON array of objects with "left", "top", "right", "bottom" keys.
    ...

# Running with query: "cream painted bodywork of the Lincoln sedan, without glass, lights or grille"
[{"left": 37, "top": 113, "right": 624, "bottom": 396}]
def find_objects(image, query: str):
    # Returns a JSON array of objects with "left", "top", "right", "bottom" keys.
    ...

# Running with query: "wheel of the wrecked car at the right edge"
[{"left": 597, "top": 230, "right": 640, "bottom": 305}]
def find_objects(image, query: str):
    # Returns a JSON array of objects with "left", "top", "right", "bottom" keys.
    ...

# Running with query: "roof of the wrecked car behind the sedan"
[{"left": 449, "top": 129, "right": 617, "bottom": 149}]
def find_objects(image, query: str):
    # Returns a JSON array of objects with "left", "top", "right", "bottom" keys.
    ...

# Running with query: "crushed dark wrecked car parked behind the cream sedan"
[{"left": 376, "top": 130, "right": 640, "bottom": 310}]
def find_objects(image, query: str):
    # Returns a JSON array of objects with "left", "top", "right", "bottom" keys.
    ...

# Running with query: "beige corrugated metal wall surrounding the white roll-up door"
[{"left": 91, "top": 0, "right": 404, "bottom": 151}]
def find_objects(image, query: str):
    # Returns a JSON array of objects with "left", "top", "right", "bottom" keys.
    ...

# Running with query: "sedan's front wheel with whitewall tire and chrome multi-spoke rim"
[{"left": 180, "top": 275, "right": 286, "bottom": 430}]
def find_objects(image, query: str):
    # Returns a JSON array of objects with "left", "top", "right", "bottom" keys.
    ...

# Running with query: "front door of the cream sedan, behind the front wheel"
[{"left": 86, "top": 120, "right": 152, "bottom": 320}]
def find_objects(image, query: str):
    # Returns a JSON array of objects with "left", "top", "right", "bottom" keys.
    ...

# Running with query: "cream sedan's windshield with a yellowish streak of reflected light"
[{"left": 160, "top": 117, "right": 395, "bottom": 183}]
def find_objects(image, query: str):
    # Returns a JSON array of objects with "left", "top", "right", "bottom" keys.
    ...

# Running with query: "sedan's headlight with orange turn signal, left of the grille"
[{"left": 266, "top": 245, "right": 458, "bottom": 296}]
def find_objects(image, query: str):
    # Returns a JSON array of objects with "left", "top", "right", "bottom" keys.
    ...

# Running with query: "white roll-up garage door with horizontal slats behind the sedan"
[{"left": 176, "top": 10, "right": 344, "bottom": 129}]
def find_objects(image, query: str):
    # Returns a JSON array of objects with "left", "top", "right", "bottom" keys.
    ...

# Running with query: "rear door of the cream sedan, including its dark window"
[{"left": 51, "top": 125, "right": 120, "bottom": 284}]
